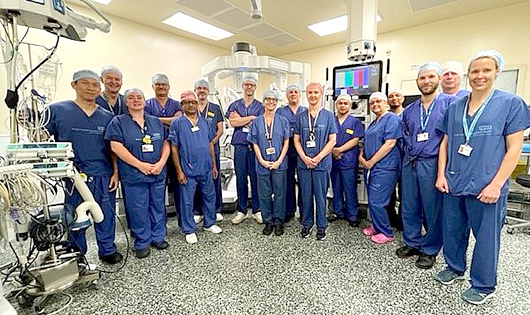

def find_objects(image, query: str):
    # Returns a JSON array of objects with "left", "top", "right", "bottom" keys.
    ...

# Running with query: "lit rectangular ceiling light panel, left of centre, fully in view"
[{"left": 164, "top": 12, "right": 234, "bottom": 41}]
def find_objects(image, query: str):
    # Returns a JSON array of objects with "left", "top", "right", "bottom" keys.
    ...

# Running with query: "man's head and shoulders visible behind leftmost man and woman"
[{"left": 96, "top": 65, "right": 127, "bottom": 116}]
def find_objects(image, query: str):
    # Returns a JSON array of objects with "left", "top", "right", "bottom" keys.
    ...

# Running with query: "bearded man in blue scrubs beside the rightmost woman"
[{"left": 396, "top": 62, "right": 456, "bottom": 269}]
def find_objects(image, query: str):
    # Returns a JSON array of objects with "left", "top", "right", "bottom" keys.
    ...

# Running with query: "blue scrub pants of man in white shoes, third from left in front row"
[{"left": 180, "top": 171, "right": 215, "bottom": 234}]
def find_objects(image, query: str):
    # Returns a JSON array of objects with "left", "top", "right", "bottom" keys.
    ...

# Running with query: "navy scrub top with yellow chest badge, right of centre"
[{"left": 333, "top": 115, "right": 364, "bottom": 170}]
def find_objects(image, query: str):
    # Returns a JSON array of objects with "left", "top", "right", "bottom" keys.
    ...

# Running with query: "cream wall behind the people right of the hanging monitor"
[{"left": 279, "top": 2, "right": 530, "bottom": 102}]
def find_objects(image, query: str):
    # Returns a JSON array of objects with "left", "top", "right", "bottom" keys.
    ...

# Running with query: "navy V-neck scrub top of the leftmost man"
[{"left": 45, "top": 101, "right": 112, "bottom": 176}]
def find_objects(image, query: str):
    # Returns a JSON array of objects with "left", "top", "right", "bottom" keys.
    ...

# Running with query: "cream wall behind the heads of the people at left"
[{"left": 0, "top": 7, "right": 229, "bottom": 134}]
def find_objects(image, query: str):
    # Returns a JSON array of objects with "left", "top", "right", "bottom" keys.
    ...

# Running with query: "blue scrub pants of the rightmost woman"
[{"left": 443, "top": 194, "right": 508, "bottom": 293}]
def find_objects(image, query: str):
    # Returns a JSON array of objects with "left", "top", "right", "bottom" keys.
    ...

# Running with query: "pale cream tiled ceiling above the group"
[{"left": 72, "top": 0, "right": 529, "bottom": 56}]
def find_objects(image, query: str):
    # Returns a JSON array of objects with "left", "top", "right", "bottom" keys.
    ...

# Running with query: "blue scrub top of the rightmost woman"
[{"left": 439, "top": 90, "right": 530, "bottom": 196}]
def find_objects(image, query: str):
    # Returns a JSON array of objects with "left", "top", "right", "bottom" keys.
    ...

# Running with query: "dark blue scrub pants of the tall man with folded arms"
[{"left": 234, "top": 145, "right": 260, "bottom": 214}]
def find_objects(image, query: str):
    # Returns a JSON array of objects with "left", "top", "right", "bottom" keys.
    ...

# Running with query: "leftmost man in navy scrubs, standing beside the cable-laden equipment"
[{"left": 45, "top": 70, "right": 123, "bottom": 264}]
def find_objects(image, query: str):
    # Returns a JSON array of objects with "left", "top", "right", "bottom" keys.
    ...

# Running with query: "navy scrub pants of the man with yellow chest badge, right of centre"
[{"left": 331, "top": 167, "right": 359, "bottom": 222}]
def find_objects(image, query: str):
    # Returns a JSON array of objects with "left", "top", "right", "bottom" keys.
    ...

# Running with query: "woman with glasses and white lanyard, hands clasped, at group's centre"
[{"left": 247, "top": 90, "right": 291, "bottom": 236}]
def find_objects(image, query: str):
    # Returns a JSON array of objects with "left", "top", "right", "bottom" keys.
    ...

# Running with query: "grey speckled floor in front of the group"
[{"left": 0, "top": 210, "right": 530, "bottom": 314}]
